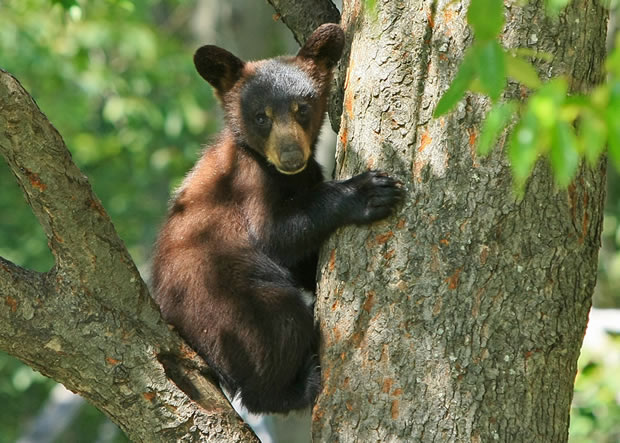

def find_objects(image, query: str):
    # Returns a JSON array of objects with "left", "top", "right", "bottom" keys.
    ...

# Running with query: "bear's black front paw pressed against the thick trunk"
[{"left": 346, "top": 171, "right": 404, "bottom": 224}]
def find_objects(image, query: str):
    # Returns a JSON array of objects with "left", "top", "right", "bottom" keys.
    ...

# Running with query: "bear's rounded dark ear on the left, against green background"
[{"left": 194, "top": 45, "right": 245, "bottom": 95}]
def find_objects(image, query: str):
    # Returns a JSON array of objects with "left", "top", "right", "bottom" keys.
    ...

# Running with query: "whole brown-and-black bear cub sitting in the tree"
[{"left": 153, "top": 24, "right": 402, "bottom": 413}]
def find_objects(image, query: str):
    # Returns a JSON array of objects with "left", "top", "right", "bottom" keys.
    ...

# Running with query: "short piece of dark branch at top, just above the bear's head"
[{"left": 267, "top": 0, "right": 340, "bottom": 45}]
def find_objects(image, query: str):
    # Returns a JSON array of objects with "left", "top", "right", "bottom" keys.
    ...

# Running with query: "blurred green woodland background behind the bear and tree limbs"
[{"left": 0, "top": 0, "right": 620, "bottom": 443}]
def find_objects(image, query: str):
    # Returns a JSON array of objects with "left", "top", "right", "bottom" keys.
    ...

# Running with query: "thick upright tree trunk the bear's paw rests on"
[{"left": 313, "top": 0, "right": 606, "bottom": 442}]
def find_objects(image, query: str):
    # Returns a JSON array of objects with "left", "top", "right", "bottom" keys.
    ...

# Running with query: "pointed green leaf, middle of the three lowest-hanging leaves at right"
[{"left": 549, "top": 120, "right": 579, "bottom": 188}]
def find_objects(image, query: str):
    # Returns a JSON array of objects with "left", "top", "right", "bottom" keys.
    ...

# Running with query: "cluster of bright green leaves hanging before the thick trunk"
[{"left": 434, "top": 0, "right": 620, "bottom": 194}]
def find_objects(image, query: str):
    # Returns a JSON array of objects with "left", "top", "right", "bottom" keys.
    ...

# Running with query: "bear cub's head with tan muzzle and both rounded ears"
[{"left": 194, "top": 23, "right": 344, "bottom": 174}]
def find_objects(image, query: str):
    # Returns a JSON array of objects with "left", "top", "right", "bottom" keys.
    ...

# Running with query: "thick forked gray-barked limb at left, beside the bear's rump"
[{"left": 0, "top": 70, "right": 255, "bottom": 442}]
